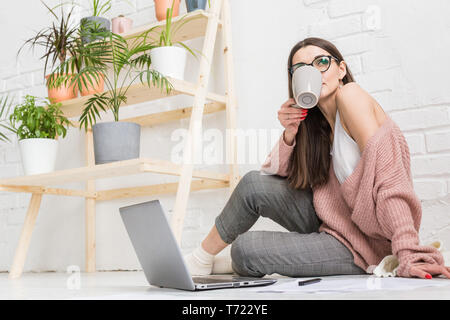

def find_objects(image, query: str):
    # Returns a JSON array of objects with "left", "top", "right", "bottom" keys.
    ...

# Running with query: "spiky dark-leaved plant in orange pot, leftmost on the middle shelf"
[{"left": 17, "top": 0, "right": 78, "bottom": 103}]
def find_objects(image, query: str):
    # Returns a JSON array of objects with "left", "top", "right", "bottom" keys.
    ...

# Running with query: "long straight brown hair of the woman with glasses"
[{"left": 287, "top": 37, "right": 354, "bottom": 189}]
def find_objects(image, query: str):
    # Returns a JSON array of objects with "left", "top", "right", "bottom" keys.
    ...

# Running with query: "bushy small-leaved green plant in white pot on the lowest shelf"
[{"left": 8, "top": 95, "right": 71, "bottom": 175}]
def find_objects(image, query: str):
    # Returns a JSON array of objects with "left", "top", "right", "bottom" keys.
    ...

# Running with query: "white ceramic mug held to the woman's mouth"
[{"left": 292, "top": 66, "right": 322, "bottom": 109}]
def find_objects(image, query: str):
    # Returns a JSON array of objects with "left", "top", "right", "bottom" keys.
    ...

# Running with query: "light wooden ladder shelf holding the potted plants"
[{"left": 0, "top": 0, "right": 241, "bottom": 278}]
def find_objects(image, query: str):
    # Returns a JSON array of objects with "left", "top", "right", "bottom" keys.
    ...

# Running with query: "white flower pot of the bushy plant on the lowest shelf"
[{"left": 19, "top": 138, "right": 58, "bottom": 175}]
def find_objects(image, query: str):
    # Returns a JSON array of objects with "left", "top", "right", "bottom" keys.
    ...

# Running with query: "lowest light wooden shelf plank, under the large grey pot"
[{"left": 0, "top": 158, "right": 229, "bottom": 188}]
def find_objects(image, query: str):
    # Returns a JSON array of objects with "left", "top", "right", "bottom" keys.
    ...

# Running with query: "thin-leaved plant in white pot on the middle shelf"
[{"left": 144, "top": 4, "right": 197, "bottom": 80}]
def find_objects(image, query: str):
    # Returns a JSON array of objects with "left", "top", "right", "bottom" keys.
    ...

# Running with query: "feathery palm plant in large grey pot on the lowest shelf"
[{"left": 62, "top": 31, "right": 173, "bottom": 164}]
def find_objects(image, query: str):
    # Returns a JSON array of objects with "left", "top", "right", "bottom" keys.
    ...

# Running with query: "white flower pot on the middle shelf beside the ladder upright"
[{"left": 150, "top": 46, "right": 187, "bottom": 80}]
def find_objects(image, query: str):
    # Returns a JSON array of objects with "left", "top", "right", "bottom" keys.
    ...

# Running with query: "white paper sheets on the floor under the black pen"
[{"left": 247, "top": 276, "right": 450, "bottom": 294}]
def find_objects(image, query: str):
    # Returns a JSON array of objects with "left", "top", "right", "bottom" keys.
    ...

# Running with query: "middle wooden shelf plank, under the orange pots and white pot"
[{"left": 61, "top": 77, "right": 226, "bottom": 118}]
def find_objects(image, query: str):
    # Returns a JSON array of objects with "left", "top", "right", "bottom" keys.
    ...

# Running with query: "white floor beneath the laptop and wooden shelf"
[{"left": 0, "top": 271, "right": 450, "bottom": 300}]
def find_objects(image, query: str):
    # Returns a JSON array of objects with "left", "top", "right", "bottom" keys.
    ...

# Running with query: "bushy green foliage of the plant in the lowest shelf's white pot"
[{"left": 9, "top": 95, "right": 71, "bottom": 140}]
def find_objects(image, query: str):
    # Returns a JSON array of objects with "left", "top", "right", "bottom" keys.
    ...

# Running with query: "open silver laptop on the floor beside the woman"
[{"left": 119, "top": 200, "right": 277, "bottom": 291}]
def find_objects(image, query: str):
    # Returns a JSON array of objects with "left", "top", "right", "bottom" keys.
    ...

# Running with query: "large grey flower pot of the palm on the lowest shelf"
[{"left": 92, "top": 121, "right": 141, "bottom": 164}]
